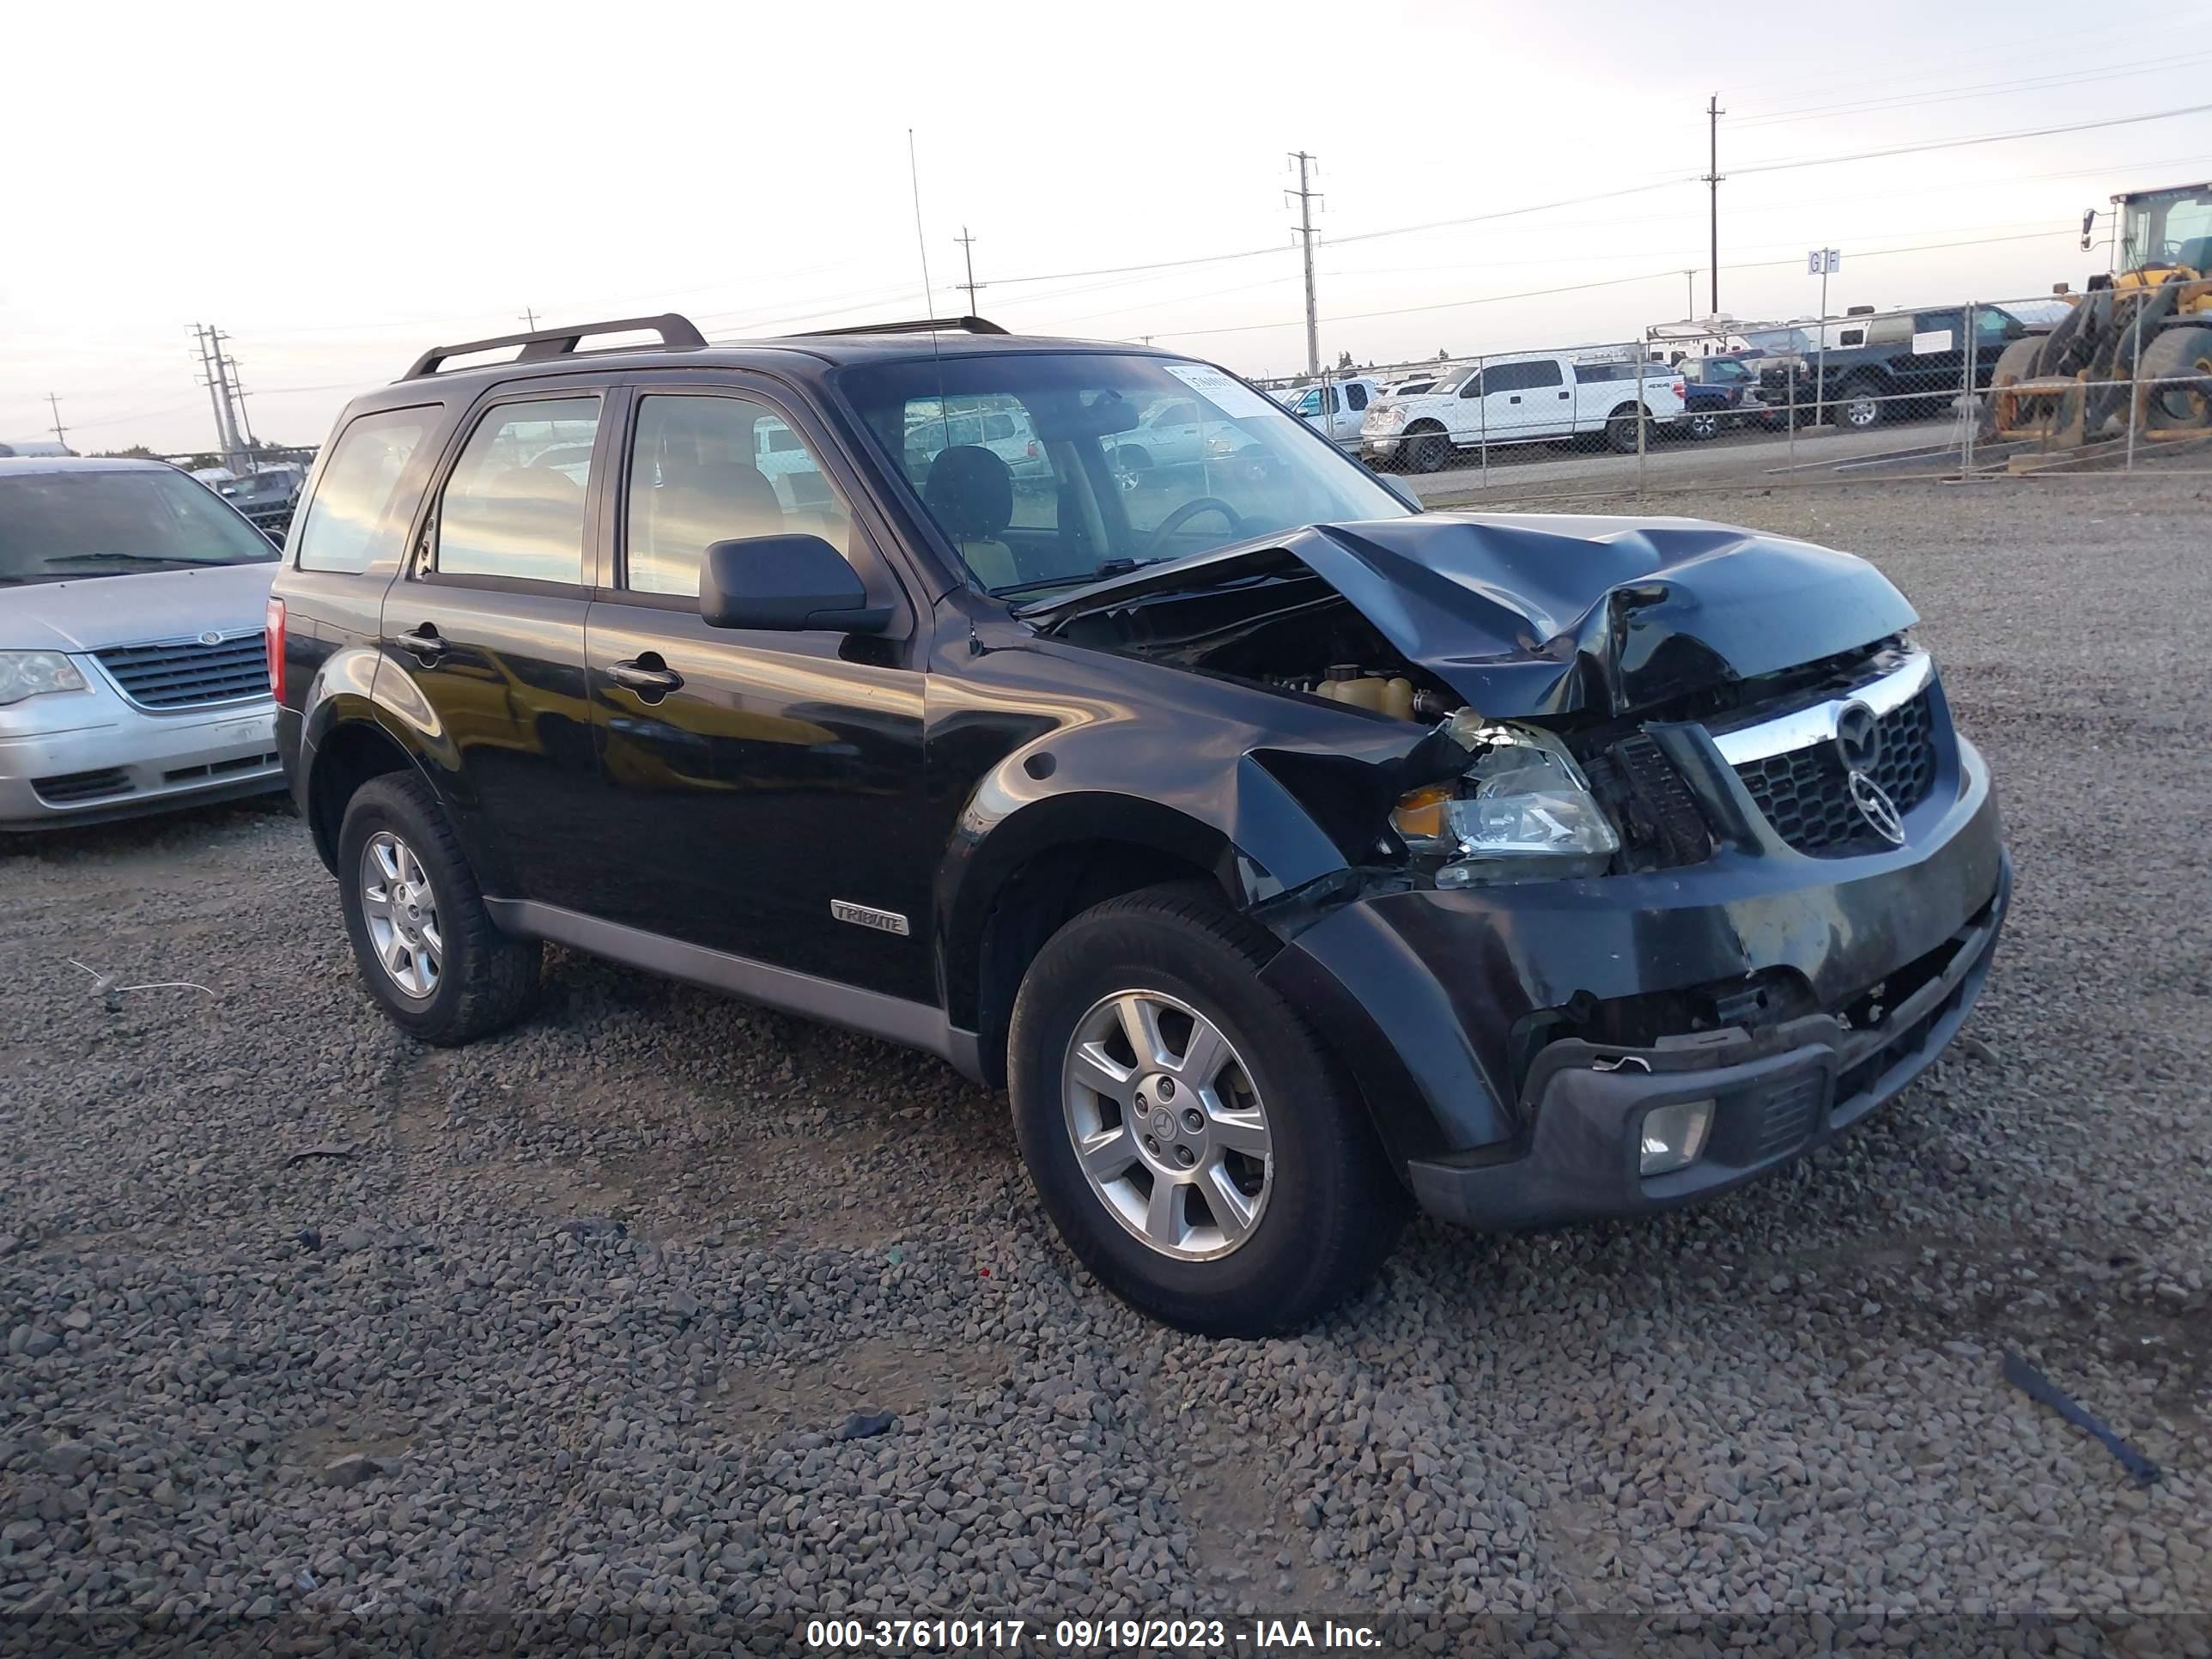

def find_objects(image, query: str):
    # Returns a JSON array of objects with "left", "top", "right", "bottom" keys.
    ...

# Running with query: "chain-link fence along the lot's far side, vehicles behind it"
[{"left": 1276, "top": 283, "right": 2212, "bottom": 498}]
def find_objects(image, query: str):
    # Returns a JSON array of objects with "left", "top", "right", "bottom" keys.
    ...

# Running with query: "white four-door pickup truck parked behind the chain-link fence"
[{"left": 1360, "top": 347, "right": 1686, "bottom": 473}]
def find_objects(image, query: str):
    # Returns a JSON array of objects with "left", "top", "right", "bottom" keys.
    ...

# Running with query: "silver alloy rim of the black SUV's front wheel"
[{"left": 1061, "top": 988, "right": 1274, "bottom": 1261}]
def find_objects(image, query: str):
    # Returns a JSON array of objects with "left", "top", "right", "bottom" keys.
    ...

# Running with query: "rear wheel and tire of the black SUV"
[{"left": 338, "top": 772, "right": 544, "bottom": 1046}]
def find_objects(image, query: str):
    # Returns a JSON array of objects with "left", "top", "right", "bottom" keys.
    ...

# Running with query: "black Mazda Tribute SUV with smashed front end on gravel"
[{"left": 270, "top": 316, "right": 2011, "bottom": 1332}]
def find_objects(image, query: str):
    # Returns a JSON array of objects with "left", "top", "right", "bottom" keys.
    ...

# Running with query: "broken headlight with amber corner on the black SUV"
[{"left": 1391, "top": 710, "right": 1621, "bottom": 887}]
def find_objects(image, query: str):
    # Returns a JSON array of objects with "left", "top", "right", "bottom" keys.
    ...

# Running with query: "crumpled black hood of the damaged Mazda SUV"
[{"left": 1022, "top": 514, "right": 1917, "bottom": 717}]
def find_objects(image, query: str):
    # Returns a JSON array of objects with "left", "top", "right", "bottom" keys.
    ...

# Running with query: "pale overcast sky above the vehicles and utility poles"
[{"left": 0, "top": 0, "right": 2212, "bottom": 452}]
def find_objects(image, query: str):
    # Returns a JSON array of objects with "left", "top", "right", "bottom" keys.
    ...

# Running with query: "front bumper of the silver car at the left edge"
[{"left": 0, "top": 695, "right": 283, "bottom": 832}]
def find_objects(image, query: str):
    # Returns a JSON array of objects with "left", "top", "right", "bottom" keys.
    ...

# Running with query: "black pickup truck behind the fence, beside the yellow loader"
[{"left": 1759, "top": 305, "right": 2031, "bottom": 431}]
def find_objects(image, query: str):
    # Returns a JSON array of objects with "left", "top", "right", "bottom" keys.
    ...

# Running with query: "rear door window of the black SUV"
[{"left": 434, "top": 398, "right": 599, "bottom": 584}]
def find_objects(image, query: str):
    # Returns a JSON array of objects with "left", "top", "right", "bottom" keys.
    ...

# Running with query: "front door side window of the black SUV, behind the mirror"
[{"left": 623, "top": 396, "right": 852, "bottom": 598}]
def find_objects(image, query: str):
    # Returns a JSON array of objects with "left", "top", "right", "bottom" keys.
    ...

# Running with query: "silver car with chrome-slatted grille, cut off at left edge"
[{"left": 0, "top": 458, "right": 283, "bottom": 830}]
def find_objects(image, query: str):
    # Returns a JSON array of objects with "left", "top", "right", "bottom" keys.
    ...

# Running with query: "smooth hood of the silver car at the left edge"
[{"left": 0, "top": 566, "right": 276, "bottom": 653}]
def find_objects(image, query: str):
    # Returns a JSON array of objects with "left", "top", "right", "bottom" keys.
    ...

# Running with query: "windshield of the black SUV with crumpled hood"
[{"left": 838, "top": 352, "right": 1411, "bottom": 592}]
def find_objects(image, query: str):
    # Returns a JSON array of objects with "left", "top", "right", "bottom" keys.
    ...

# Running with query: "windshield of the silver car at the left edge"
[{"left": 0, "top": 469, "right": 276, "bottom": 584}]
